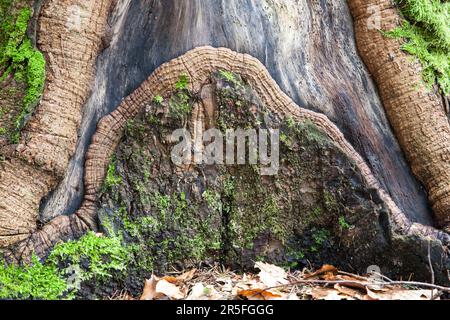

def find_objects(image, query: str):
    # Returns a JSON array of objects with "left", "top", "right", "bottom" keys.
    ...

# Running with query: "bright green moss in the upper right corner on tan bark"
[{"left": 385, "top": 0, "right": 450, "bottom": 95}]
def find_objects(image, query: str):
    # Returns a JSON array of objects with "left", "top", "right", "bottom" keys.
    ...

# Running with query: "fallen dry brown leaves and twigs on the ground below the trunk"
[{"left": 108, "top": 262, "right": 450, "bottom": 300}]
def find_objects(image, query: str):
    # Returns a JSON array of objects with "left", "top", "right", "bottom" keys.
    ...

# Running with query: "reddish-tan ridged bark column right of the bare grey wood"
[{"left": 348, "top": 0, "right": 450, "bottom": 231}]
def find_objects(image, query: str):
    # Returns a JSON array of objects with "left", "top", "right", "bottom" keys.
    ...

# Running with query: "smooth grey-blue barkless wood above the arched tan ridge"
[{"left": 41, "top": 0, "right": 432, "bottom": 224}]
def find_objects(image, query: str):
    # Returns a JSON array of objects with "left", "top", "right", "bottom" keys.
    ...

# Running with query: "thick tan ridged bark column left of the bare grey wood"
[{"left": 0, "top": 0, "right": 111, "bottom": 255}]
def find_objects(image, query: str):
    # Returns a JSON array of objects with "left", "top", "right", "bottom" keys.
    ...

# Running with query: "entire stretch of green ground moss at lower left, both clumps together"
[{"left": 0, "top": 232, "right": 131, "bottom": 300}]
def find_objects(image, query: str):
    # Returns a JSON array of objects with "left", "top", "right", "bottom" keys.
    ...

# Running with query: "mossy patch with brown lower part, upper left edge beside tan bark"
[{"left": 0, "top": 0, "right": 45, "bottom": 143}]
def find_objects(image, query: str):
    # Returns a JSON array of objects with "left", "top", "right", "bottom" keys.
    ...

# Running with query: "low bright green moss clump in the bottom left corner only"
[{"left": 0, "top": 256, "right": 67, "bottom": 300}]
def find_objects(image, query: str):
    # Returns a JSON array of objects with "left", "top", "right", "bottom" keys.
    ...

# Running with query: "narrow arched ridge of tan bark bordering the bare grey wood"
[{"left": 4, "top": 47, "right": 449, "bottom": 260}]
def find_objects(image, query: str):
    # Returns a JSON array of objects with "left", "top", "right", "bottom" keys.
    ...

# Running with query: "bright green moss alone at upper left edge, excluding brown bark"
[{"left": 0, "top": 1, "right": 45, "bottom": 143}]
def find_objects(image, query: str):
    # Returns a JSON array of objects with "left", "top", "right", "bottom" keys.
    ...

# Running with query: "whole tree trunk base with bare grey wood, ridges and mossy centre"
[{"left": 0, "top": 0, "right": 450, "bottom": 292}]
